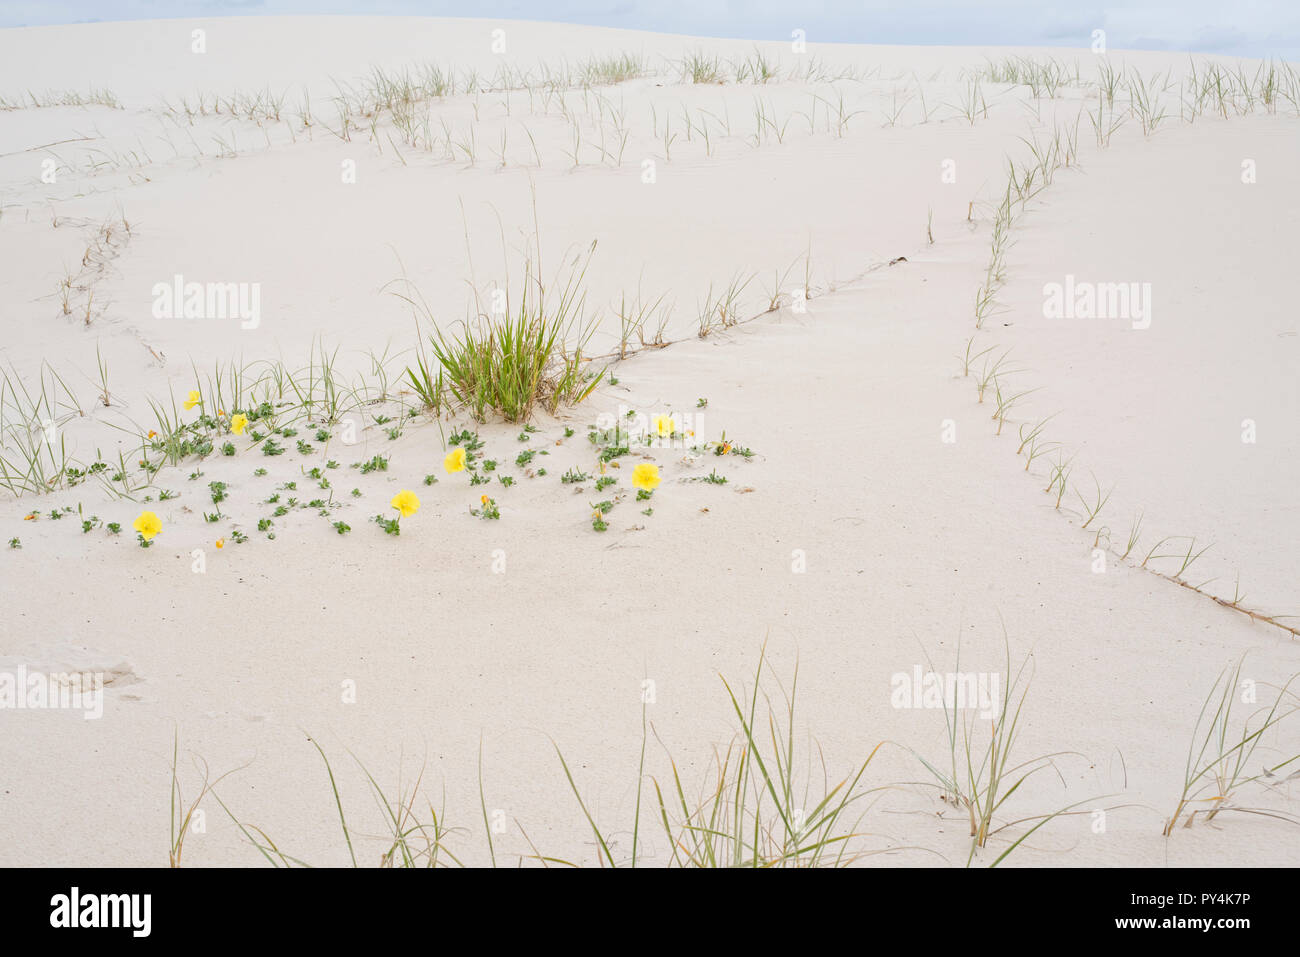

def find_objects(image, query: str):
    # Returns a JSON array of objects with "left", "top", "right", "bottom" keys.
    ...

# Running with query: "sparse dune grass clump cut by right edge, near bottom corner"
[{"left": 1164, "top": 657, "right": 1300, "bottom": 837}]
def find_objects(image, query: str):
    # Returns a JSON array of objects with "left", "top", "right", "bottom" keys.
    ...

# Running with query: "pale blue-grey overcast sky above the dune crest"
[{"left": 0, "top": 0, "right": 1300, "bottom": 60}]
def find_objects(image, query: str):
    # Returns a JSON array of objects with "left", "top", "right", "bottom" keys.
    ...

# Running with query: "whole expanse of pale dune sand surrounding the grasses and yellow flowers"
[{"left": 0, "top": 20, "right": 1300, "bottom": 865}]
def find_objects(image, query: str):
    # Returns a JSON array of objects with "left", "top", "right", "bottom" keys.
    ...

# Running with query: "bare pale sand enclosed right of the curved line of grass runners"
[{"left": 1000, "top": 117, "right": 1300, "bottom": 614}]
